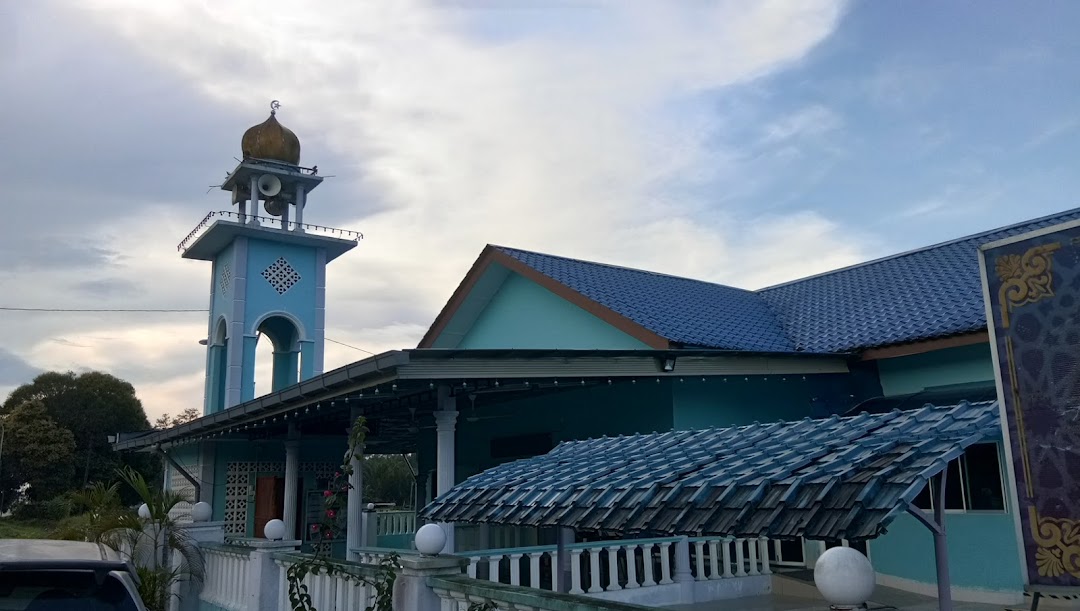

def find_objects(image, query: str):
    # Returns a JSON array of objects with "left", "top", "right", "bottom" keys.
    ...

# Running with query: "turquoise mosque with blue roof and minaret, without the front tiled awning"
[{"left": 114, "top": 108, "right": 1080, "bottom": 602}]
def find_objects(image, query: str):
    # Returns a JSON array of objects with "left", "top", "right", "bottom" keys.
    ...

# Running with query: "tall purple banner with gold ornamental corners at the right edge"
[{"left": 983, "top": 225, "right": 1080, "bottom": 586}]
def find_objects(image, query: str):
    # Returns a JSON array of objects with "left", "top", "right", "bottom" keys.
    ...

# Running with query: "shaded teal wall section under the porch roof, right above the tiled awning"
[{"left": 672, "top": 374, "right": 864, "bottom": 430}]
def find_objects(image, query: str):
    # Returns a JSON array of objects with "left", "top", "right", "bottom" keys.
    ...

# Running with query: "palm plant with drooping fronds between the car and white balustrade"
[{"left": 98, "top": 467, "right": 204, "bottom": 611}]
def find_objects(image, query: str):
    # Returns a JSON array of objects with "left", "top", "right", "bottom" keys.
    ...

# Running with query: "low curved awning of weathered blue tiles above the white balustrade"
[{"left": 421, "top": 402, "right": 999, "bottom": 540}]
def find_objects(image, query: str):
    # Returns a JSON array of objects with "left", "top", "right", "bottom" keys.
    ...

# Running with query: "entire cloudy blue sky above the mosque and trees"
[{"left": 0, "top": 0, "right": 1080, "bottom": 420}]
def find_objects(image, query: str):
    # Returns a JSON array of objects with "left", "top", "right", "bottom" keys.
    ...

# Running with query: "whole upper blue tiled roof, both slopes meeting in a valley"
[{"left": 496, "top": 209, "right": 1080, "bottom": 353}]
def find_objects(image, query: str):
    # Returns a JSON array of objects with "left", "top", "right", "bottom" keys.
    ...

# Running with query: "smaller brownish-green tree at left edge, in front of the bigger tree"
[{"left": 0, "top": 400, "right": 75, "bottom": 504}]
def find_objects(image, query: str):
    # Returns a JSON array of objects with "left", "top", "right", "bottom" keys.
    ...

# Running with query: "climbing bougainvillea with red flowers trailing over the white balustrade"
[{"left": 286, "top": 417, "right": 401, "bottom": 611}]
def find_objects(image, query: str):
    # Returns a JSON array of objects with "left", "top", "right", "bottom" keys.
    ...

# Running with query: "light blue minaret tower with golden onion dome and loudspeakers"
[{"left": 179, "top": 100, "right": 362, "bottom": 415}]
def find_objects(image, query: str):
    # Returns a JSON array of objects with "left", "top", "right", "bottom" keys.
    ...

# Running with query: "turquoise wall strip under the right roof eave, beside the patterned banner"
[{"left": 877, "top": 343, "right": 994, "bottom": 396}]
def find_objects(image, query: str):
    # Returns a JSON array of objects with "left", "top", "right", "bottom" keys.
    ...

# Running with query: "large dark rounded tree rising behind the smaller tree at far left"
[{"left": 0, "top": 371, "right": 160, "bottom": 500}]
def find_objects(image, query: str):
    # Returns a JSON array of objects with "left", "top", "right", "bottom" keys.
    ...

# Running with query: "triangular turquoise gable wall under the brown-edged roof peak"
[{"left": 457, "top": 273, "right": 649, "bottom": 350}]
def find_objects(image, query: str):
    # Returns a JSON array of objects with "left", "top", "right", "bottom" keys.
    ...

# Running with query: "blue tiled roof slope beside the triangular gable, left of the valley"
[{"left": 497, "top": 246, "right": 792, "bottom": 352}]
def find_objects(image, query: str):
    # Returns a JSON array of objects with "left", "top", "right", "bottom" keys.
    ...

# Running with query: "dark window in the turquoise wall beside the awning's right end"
[{"left": 914, "top": 444, "right": 1005, "bottom": 512}]
